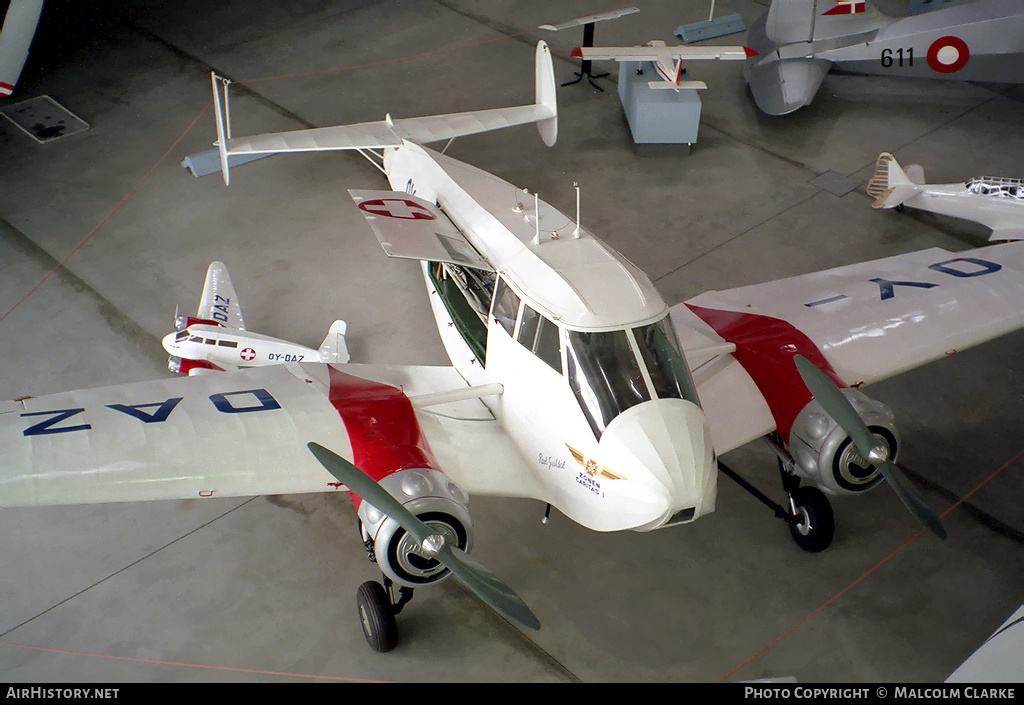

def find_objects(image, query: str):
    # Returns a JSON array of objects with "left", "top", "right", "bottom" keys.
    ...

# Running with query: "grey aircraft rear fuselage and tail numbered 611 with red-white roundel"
[{"left": 743, "top": 0, "right": 1024, "bottom": 115}]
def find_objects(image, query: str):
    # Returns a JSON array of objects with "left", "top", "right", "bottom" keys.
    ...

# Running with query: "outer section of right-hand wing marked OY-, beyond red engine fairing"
[{"left": 686, "top": 243, "right": 1024, "bottom": 386}]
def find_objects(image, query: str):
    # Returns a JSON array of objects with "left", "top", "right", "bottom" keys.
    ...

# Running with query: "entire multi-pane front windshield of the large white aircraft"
[{"left": 565, "top": 317, "right": 698, "bottom": 439}]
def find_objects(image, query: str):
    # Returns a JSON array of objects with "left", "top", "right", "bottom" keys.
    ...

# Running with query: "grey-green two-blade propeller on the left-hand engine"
[{"left": 306, "top": 442, "right": 541, "bottom": 629}]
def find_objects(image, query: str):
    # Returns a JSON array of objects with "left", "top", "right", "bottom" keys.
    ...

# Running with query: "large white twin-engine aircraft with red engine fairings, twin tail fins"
[{"left": 0, "top": 42, "right": 1024, "bottom": 651}]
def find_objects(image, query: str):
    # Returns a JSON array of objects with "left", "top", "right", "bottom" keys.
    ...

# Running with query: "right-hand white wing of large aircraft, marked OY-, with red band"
[{"left": 671, "top": 242, "right": 1024, "bottom": 453}]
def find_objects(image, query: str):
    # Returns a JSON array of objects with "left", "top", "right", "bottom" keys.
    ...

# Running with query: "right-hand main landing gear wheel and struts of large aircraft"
[{"left": 718, "top": 460, "right": 836, "bottom": 552}]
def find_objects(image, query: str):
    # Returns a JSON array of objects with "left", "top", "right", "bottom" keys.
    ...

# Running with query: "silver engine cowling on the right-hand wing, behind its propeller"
[{"left": 786, "top": 388, "right": 899, "bottom": 495}]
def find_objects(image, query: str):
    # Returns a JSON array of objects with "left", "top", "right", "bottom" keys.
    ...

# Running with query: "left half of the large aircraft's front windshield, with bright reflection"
[{"left": 565, "top": 330, "right": 650, "bottom": 439}]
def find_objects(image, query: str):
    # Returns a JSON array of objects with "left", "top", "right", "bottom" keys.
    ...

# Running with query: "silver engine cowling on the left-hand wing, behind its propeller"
[{"left": 358, "top": 468, "right": 473, "bottom": 587}]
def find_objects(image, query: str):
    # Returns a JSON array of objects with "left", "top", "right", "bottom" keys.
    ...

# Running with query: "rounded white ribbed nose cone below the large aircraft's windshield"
[{"left": 598, "top": 399, "right": 718, "bottom": 531}]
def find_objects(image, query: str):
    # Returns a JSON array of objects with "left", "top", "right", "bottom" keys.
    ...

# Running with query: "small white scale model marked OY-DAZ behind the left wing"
[{"left": 162, "top": 262, "right": 348, "bottom": 375}]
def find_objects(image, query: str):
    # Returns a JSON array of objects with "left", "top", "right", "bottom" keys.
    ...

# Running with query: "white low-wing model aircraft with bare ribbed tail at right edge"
[{"left": 867, "top": 152, "right": 1024, "bottom": 240}]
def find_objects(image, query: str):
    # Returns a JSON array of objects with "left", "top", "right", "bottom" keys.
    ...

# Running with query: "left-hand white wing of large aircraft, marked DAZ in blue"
[{"left": 0, "top": 364, "right": 536, "bottom": 506}]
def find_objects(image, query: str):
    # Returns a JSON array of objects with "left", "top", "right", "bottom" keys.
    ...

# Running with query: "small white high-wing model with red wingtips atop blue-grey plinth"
[{"left": 571, "top": 39, "right": 757, "bottom": 92}]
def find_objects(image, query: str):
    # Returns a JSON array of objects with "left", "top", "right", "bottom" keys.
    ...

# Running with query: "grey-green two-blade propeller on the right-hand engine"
[{"left": 793, "top": 355, "right": 946, "bottom": 539}]
